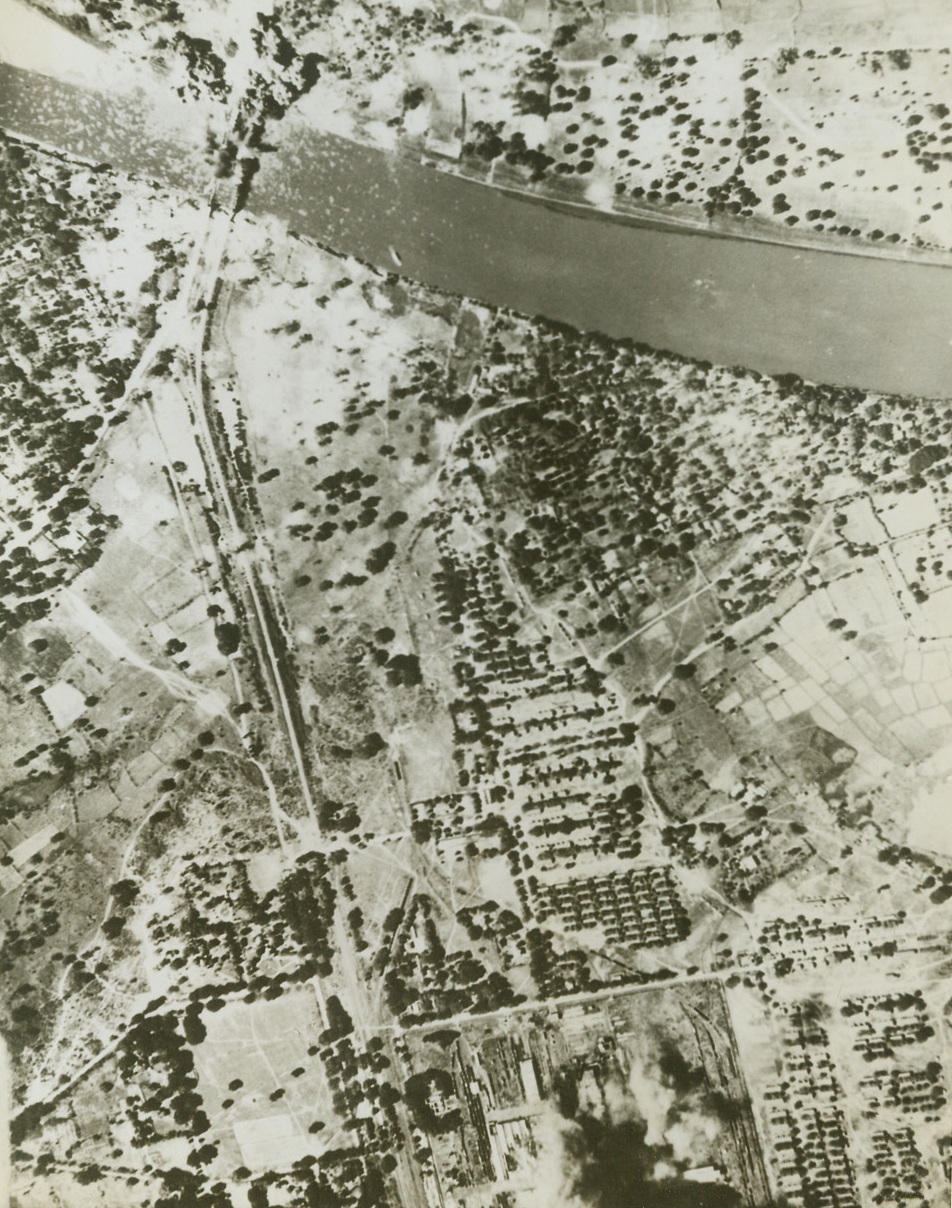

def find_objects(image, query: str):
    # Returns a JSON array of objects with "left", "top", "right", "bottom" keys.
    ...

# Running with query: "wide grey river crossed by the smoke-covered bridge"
[{"left": 0, "top": 65, "right": 952, "bottom": 396}]
